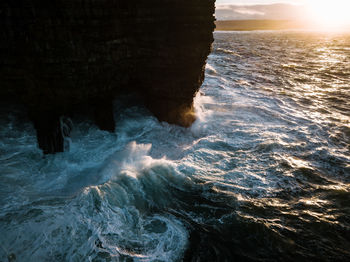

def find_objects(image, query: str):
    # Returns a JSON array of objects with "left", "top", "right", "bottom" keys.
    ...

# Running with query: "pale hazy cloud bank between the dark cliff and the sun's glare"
[{"left": 216, "top": 4, "right": 305, "bottom": 20}]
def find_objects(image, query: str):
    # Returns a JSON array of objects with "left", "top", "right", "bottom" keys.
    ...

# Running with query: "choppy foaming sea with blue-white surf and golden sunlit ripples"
[{"left": 0, "top": 32, "right": 350, "bottom": 261}]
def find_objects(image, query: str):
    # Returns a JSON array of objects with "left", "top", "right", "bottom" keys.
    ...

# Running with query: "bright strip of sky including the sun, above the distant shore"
[{"left": 215, "top": 0, "right": 350, "bottom": 30}]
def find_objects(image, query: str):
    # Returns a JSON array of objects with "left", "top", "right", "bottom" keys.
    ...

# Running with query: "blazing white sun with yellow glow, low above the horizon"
[{"left": 307, "top": 0, "right": 350, "bottom": 30}]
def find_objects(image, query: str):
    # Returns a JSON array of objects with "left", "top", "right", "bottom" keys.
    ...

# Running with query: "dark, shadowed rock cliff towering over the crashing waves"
[{"left": 0, "top": 0, "right": 215, "bottom": 153}]
